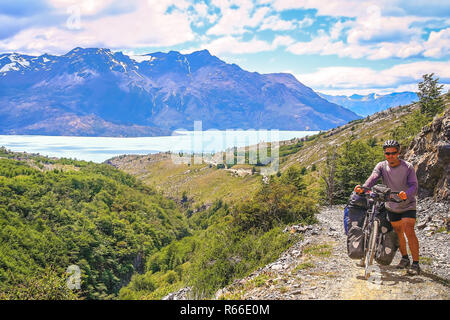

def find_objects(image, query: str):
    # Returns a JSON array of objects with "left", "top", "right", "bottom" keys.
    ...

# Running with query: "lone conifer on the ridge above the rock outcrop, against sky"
[{"left": 417, "top": 73, "right": 444, "bottom": 117}]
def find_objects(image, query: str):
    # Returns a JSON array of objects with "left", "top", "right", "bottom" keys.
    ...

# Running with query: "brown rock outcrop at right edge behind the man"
[{"left": 405, "top": 108, "right": 450, "bottom": 202}]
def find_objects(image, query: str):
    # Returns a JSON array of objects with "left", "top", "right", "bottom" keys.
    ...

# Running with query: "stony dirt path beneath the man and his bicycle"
[{"left": 216, "top": 207, "right": 450, "bottom": 300}]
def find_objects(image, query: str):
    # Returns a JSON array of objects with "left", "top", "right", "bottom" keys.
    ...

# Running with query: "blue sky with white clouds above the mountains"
[{"left": 0, "top": 0, "right": 450, "bottom": 95}]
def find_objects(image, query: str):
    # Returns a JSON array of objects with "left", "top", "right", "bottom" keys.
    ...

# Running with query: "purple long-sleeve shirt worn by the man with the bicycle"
[{"left": 364, "top": 159, "right": 419, "bottom": 213}]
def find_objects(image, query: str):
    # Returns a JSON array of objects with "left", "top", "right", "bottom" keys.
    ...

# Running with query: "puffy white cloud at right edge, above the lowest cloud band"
[{"left": 287, "top": 17, "right": 450, "bottom": 60}]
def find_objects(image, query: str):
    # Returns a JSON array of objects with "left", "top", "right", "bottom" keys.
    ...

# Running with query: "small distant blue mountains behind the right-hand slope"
[{"left": 319, "top": 91, "right": 419, "bottom": 116}]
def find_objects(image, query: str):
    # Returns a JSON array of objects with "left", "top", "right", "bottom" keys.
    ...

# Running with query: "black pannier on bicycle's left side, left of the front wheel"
[{"left": 347, "top": 192, "right": 368, "bottom": 259}]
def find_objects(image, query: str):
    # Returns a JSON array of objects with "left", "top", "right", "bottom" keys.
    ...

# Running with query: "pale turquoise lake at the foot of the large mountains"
[{"left": 0, "top": 130, "right": 318, "bottom": 163}]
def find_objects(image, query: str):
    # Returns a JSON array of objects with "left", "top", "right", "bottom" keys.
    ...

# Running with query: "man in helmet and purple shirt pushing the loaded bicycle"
[{"left": 355, "top": 140, "right": 420, "bottom": 275}]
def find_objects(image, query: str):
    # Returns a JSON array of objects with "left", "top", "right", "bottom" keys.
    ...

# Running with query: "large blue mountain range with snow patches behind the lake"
[{"left": 0, "top": 48, "right": 360, "bottom": 136}]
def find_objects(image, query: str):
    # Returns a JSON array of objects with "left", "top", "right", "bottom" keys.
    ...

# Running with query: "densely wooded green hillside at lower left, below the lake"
[{"left": 0, "top": 148, "right": 189, "bottom": 299}]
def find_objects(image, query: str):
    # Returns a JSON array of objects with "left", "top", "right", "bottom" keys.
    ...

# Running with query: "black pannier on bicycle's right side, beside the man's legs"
[{"left": 375, "top": 210, "right": 399, "bottom": 265}]
